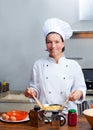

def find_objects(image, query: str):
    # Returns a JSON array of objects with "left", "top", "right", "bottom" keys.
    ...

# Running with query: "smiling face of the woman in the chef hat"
[{"left": 46, "top": 33, "right": 64, "bottom": 60}]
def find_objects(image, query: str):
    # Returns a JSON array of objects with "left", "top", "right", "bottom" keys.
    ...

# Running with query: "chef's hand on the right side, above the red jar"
[{"left": 68, "top": 90, "right": 83, "bottom": 101}]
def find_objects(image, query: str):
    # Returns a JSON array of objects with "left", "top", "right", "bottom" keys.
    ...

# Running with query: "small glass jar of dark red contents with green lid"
[{"left": 68, "top": 109, "right": 77, "bottom": 126}]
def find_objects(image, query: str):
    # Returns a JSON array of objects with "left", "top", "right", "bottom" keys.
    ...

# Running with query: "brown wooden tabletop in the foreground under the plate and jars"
[{"left": 0, "top": 115, "right": 91, "bottom": 130}]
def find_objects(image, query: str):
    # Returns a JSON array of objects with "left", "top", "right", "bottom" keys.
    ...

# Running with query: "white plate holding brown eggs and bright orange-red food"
[{"left": 0, "top": 110, "right": 29, "bottom": 123}]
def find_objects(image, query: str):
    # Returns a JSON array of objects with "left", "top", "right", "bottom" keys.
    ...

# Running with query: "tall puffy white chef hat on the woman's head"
[{"left": 43, "top": 18, "right": 72, "bottom": 41}]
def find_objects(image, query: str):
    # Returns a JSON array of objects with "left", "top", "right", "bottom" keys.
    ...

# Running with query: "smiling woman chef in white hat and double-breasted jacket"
[{"left": 24, "top": 18, "right": 86, "bottom": 109}]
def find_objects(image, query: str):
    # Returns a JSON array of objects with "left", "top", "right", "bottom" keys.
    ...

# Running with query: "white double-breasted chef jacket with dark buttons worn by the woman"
[{"left": 30, "top": 57, "right": 86, "bottom": 109}]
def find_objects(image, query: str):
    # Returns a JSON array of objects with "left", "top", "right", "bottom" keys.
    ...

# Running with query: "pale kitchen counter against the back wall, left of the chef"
[{"left": 0, "top": 90, "right": 35, "bottom": 112}]
